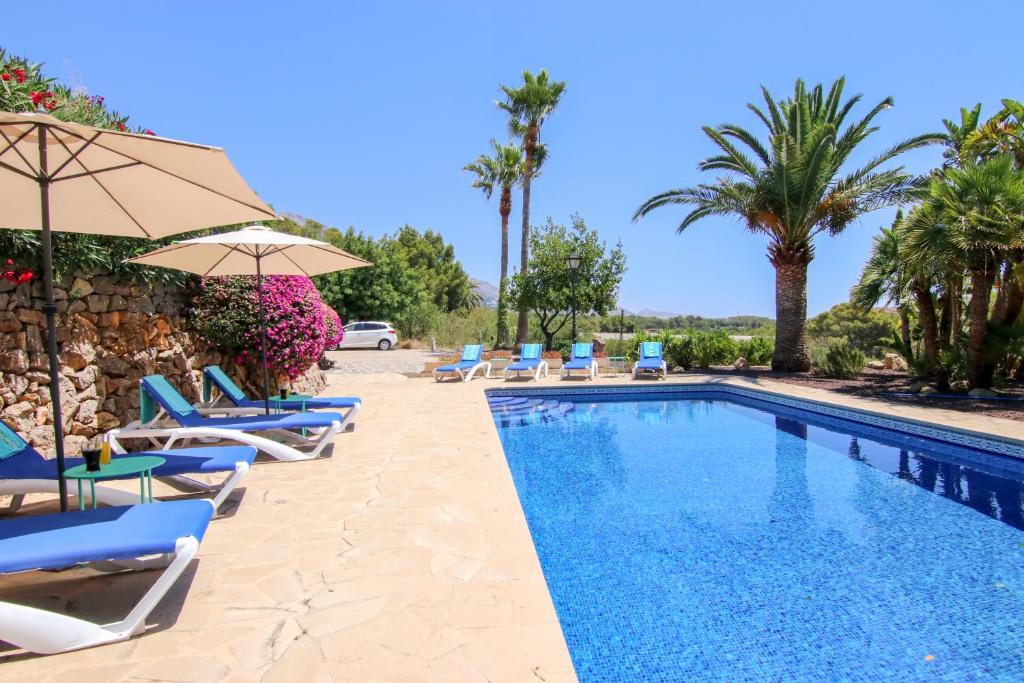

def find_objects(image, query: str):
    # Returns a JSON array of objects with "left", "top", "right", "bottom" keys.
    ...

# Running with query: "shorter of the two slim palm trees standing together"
[{"left": 463, "top": 140, "right": 523, "bottom": 348}]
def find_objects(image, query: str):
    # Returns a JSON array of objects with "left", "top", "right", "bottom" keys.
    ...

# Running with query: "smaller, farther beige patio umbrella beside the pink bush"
[{"left": 128, "top": 225, "right": 373, "bottom": 415}]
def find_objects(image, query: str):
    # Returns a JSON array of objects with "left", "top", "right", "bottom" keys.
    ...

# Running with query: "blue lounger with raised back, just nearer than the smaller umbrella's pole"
[{"left": 111, "top": 375, "right": 344, "bottom": 460}]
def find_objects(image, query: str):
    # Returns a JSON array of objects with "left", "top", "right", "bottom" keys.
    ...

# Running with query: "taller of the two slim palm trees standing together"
[{"left": 498, "top": 69, "right": 565, "bottom": 344}]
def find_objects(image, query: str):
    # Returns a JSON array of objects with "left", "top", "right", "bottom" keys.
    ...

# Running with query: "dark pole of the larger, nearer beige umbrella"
[{"left": 38, "top": 126, "right": 68, "bottom": 512}]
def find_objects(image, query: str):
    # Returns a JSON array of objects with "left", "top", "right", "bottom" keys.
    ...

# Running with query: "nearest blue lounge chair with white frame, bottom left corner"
[{"left": 0, "top": 501, "right": 213, "bottom": 654}]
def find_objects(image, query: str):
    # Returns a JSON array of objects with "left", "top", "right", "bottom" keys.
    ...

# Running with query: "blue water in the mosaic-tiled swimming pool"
[{"left": 492, "top": 394, "right": 1024, "bottom": 683}]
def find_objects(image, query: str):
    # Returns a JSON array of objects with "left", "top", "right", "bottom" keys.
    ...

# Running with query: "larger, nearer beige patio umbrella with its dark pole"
[{"left": 0, "top": 112, "right": 275, "bottom": 510}]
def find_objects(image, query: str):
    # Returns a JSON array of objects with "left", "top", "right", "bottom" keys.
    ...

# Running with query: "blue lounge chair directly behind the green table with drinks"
[{"left": 0, "top": 422, "right": 256, "bottom": 512}]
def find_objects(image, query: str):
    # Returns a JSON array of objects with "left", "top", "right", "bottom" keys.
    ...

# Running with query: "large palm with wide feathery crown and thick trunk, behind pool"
[{"left": 633, "top": 78, "right": 944, "bottom": 372}]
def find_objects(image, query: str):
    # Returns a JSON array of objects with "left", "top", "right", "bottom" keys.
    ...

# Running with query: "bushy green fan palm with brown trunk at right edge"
[{"left": 905, "top": 155, "right": 1024, "bottom": 389}]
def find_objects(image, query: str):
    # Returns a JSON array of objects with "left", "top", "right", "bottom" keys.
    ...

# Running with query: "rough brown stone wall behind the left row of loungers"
[{"left": 0, "top": 274, "right": 325, "bottom": 454}]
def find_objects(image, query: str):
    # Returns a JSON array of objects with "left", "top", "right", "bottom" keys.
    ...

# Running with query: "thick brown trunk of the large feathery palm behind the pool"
[{"left": 771, "top": 253, "right": 811, "bottom": 373}]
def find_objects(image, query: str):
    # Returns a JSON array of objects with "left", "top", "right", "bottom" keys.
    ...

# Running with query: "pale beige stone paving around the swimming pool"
[{"left": 0, "top": 370, "right": 1024, "bottom": 683}]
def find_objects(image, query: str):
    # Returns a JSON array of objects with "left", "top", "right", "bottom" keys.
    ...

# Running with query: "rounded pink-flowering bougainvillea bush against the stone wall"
[{"left": 193, "top": 275, "right": 343, "bottom": 380}]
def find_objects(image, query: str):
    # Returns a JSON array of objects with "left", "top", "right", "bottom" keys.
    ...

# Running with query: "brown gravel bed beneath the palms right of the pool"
[{"left": 699, "top": 368, "right": 1024, "bottom": 420}]
